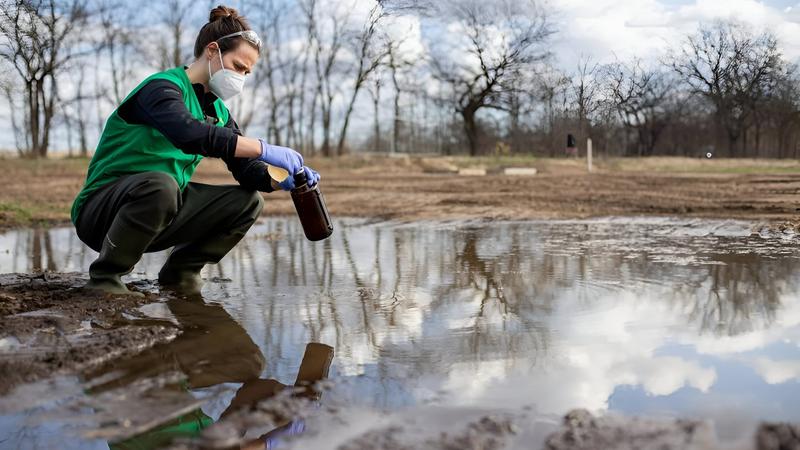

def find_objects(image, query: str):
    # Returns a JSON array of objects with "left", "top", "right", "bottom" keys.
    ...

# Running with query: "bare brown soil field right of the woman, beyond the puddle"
[{"left": 197, "top": 159, "right": 800, "bottom": 222}]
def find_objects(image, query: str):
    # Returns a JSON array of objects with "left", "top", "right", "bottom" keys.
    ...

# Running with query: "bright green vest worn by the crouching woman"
[{"left": 70, "top": 67, "right": 229, "bottom": 223}]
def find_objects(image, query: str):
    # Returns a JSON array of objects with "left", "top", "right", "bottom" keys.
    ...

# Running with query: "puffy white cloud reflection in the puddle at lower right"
[{"left": 444, "top": 291, "right": 717, "bottom": 414}]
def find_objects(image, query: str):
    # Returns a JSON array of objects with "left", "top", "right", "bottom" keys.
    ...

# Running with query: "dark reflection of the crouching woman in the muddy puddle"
[{"left": 84, "top": 297, "right": 333, "bottom": 449}]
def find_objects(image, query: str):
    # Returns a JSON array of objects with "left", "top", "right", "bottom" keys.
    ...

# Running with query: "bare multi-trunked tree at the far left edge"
[{"left": 0, "top": 0, "right": 87, "bottom": 158}]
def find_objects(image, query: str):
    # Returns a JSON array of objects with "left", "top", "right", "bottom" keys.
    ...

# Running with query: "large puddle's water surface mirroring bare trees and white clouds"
[{"left": 0, "top": 219, "right": 800, "bottom": 432}]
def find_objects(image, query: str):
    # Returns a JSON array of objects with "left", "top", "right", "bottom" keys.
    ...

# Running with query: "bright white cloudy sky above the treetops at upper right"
[{"left": 549, "top": 0, "right": 800, "bottom": 69}]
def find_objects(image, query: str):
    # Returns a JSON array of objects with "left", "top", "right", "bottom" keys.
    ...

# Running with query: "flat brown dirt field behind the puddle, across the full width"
[{"left": 0, "top": 156, "right": 800, "bottom": 232}]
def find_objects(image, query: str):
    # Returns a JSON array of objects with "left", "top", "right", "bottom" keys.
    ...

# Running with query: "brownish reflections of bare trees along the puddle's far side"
[{"left": 4, "top": 219, "right": 797, "bottom": 356}]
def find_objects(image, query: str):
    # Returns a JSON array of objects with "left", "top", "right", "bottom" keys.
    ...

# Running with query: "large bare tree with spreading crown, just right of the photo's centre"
[{"left": 431, "top": 0, "right": 553, "bottom": 155}]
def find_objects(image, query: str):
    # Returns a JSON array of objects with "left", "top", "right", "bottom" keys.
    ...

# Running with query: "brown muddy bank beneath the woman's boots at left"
[{"left": 0, "top": 273, "right": 179, "bottom": 398}]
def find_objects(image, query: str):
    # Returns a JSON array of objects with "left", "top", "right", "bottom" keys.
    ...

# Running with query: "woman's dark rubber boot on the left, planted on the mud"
[{"left": 84, "top": 220, "right": 153, "bottom": 297}]
